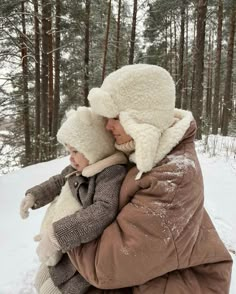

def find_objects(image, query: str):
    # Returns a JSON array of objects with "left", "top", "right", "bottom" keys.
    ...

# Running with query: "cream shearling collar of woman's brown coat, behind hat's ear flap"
[{"left": 129, "top": 109, "right": 193, "bottom": 179}]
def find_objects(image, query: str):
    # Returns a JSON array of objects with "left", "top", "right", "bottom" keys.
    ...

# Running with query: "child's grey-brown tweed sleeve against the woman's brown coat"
[{"left": 53, "top": 165, "right": 126, "bottom": 251}]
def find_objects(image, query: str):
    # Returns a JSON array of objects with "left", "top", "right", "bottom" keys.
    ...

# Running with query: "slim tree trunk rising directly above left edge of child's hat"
[{"left": 52, "top": 0, "right": 61, "bottom": 157}]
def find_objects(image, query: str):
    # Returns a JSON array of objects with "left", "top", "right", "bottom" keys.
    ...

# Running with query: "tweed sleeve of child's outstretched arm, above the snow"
[{"left": 25, "top": 166, "right": 74, "bottom": 209}]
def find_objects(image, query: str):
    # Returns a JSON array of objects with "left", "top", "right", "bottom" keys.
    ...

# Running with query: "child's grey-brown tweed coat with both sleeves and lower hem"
[{"left": 26, "top": 165, "right": 126, "bottom": 294}]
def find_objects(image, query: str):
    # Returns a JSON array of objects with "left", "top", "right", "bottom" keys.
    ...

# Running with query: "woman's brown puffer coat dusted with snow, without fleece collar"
[{"left": 68, "top": 122, "right": 232, "bottom": 294}]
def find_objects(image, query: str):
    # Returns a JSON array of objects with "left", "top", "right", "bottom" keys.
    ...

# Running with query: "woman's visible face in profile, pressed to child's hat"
[{"left": 106, "top": 117, "right": 132, "bottom": 145}]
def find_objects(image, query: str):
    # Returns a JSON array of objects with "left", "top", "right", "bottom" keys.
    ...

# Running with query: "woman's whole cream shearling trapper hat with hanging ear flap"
[{"left": 88, "top": 64, "right": 175, "bottom": 174}]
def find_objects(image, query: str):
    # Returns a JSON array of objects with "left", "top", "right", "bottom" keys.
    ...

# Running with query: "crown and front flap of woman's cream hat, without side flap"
[{"left": 88, "top": 64, "right": 175, "bottom": 128}]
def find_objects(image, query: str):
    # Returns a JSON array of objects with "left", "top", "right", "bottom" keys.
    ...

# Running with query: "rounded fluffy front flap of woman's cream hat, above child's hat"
[{"left": 88, "top": 88, "right": 119, "bottom": 118}]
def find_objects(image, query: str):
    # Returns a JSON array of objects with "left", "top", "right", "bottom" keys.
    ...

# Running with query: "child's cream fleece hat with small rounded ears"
[{"left": 57, "top": 107, "right": 115, "bottom": 164}]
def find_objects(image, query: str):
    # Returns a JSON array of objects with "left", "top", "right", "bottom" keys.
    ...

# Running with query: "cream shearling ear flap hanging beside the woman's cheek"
[{"left": 120, "top": 112, "right": 161, "bottom": 172}]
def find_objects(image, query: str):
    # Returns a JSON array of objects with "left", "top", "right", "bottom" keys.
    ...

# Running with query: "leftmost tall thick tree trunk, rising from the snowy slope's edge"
[{"left": 21, "top": 0, "right": 31, "bottom": 166}]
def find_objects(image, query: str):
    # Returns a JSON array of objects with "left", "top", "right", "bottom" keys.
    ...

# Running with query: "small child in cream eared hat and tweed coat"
[{"left": 20, "top": 107, "right": 127, "bottom": 294}]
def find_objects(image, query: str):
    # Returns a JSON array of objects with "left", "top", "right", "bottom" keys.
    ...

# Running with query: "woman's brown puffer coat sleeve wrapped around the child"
[{"left": 68, "top": 163, "right": 195, "bottom": 289}]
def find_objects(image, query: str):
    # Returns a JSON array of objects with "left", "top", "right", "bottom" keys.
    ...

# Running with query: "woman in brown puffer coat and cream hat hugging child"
[{"left": 69, "top": 64, "right": 232, "bottom": 294}]
